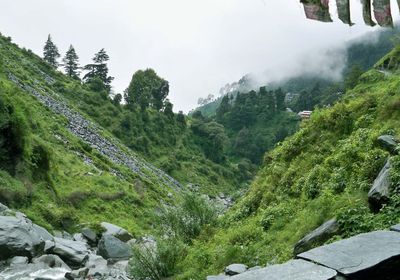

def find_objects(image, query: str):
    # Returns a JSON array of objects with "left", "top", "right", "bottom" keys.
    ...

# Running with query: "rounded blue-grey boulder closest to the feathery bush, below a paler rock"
[{"left": 98, "top": 234, "right": 132, "bottom": 260}]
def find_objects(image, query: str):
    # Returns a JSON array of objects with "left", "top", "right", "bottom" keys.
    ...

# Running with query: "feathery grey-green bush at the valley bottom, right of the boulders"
[{"left": 130, "top": 193, "right": 217, "bottom": 280}]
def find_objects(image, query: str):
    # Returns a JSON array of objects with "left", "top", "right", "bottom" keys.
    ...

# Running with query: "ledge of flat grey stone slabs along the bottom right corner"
[{"left": 207, "top": 230, "right": 400, "bottom": 280}]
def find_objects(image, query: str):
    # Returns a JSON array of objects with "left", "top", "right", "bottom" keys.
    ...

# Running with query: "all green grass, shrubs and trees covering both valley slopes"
[{"left": 0, "top": 25, "right": 400, "bottom": 279}]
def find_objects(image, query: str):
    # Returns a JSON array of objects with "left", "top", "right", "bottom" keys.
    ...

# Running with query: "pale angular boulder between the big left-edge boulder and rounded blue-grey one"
[{"left": 50, "top": 237, "right": 89, "bottom": 265}]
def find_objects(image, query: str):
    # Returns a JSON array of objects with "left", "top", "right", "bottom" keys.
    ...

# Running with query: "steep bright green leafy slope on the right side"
[{"left": 181, "top": 51, "right": 400, "bottom": 279}]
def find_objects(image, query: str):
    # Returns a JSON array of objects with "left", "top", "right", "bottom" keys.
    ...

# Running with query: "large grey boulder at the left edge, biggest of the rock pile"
[{"left": 0, "top": 216, "right": 45, "bottom": 260}]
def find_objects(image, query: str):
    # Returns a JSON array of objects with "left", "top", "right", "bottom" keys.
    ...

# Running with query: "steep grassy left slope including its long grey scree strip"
[{"left": 0, "top": 34, "right": 181, "bottom": 234}]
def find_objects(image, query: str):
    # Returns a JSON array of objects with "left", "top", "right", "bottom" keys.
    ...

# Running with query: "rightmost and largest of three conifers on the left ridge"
[{"left": 83, "top": 49, "right": 114, "bottom": 91}]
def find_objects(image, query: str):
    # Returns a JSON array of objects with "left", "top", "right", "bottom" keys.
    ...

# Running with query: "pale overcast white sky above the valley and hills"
[{"left": 0, "top": 0, "right": 398, "bottom": 112}]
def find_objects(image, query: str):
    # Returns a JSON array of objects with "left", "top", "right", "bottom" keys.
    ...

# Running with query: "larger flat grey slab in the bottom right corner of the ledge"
[{"left": 297, "top": 231, "right": 400, "bottom": 280}]
